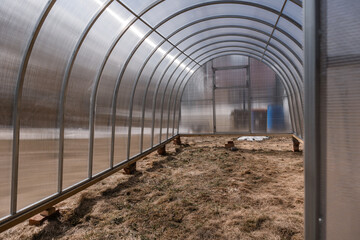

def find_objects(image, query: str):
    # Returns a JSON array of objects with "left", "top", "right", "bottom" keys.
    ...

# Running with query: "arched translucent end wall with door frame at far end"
[{"left": 180, "top": 55, "right": 292, "bottom": 136}]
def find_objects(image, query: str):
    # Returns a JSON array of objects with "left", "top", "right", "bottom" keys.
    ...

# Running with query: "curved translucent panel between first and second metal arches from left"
[{"left": 18, "top": 1, "right": 105, "bottom": 209}]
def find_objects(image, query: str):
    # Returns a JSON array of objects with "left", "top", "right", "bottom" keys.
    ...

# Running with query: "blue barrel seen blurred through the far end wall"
[{"left": 267, "top": 104, "right": 285, "bottom": 132}]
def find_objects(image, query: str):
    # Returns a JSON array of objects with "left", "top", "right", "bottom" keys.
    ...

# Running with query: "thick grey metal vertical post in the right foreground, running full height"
[{"left": 304, "top": 1, "right": 326, "bottom": 240}]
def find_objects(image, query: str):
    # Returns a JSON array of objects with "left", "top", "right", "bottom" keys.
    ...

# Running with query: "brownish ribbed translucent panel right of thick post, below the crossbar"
[{"left": 321, "top": 64, "right": 360, "bottom": 239}]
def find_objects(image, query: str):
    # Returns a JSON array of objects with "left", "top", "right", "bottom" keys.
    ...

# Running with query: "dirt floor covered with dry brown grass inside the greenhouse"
[{"left": 0, "top": 137, "right": 304, "bottom": 240}]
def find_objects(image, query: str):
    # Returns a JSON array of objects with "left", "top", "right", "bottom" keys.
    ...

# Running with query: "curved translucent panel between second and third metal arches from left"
[{"left": 57, "top": 1, "right": 104, "bottom": 189}]
